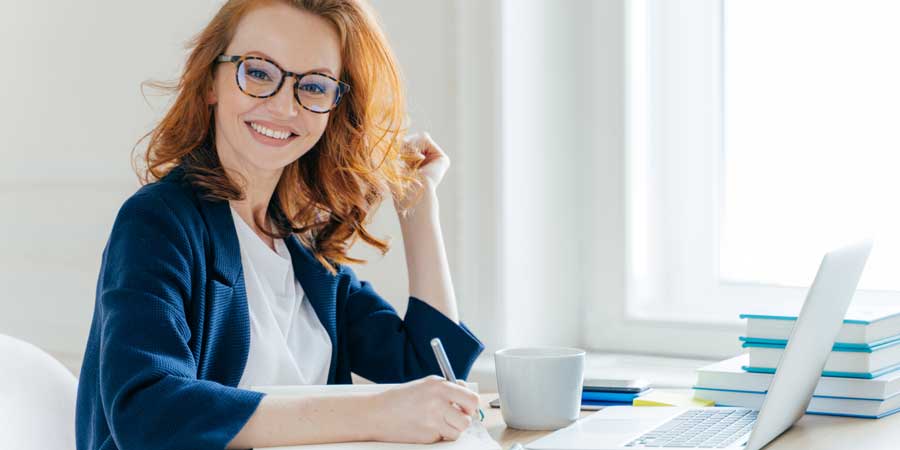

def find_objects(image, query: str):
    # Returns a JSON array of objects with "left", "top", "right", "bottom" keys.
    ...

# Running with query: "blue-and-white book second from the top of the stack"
[{"left": 743, "top": 341, "right": 900, "bottom": 378}]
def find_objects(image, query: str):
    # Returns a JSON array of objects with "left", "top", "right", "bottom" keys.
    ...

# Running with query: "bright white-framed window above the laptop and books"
[{"left": 625, "top": 0, "right": 900, "bottom": 336}]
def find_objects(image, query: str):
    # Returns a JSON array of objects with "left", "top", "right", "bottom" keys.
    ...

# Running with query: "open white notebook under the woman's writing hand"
[{"left": 251, "top": 383, "right": 501, "bottom": 450}]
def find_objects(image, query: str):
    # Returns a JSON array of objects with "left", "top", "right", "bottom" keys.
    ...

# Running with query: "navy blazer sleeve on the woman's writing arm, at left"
[{"left": 98, "top": 192, "right": 263, "bottom": 450}]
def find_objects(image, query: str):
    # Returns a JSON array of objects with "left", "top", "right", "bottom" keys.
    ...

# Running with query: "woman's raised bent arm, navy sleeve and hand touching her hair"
[{"left": 339, "top": 132, "right": 484, "bottom": 383}]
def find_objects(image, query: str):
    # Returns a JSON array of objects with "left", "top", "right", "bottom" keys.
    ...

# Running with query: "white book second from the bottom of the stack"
[{"left": 696, "top": 354, "right": 900, "bottom": 400}]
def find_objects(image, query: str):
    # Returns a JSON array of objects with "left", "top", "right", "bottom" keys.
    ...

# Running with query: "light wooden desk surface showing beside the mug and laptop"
[{"left": 481, "top": 393, "right": 900, "bottom": 450}]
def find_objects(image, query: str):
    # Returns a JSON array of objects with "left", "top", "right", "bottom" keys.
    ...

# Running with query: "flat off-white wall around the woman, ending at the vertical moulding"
[{"left": 0, "top": 0, "right": 478, "bottom": 371}]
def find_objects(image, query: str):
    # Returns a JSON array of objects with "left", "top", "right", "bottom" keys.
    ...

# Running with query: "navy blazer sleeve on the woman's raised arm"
[{"left": 342, "top": 266, "right": 484, "bottom": 383}]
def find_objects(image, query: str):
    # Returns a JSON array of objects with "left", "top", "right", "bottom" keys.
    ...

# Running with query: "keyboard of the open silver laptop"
[{"left": 625, "top": 408, "right": 757, "bottom": 448}]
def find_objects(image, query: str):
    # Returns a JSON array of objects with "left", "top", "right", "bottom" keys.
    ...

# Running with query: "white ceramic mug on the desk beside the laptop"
[{"left": 494, "top": 347, "right": 584, "bottom": 430}]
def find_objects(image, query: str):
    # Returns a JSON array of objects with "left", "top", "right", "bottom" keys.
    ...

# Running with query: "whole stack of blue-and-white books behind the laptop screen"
[{"left": 694, "top": 306, "right": 900, "bottom": 419}]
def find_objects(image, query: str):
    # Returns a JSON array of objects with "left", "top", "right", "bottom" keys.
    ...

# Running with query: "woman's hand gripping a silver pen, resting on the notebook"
[{"left": 373, "top": 375, "right": 478, "bottom": 444}]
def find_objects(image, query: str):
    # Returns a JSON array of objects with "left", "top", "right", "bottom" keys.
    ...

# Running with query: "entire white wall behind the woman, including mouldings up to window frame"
[{"left": 0, "top": 0, "right": 625, "bottom": 380}]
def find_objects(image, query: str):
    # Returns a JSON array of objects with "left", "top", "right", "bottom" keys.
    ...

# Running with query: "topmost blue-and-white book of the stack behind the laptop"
[{"left": 740, "top": 305, "right": 900, "bottom": 346}]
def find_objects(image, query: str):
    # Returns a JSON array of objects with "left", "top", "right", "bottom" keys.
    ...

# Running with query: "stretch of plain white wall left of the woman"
[{"left": 0, "top": 0, "right": 224, "bottom": 369}]
